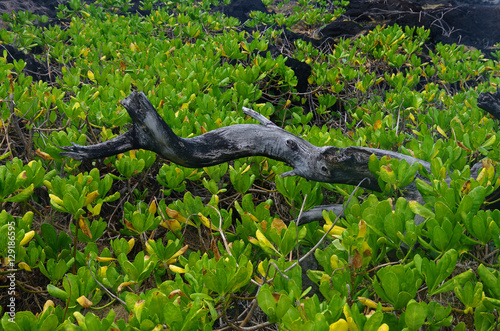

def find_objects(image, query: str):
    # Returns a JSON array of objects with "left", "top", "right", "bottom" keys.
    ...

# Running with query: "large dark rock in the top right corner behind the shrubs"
[{"left": 344, "top": 0, "right": 500, "bottom": 56}]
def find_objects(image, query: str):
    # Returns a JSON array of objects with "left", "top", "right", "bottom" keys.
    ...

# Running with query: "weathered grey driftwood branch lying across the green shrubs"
[{"left": 61, "top": 92, "right": 500, "bottom": 223}]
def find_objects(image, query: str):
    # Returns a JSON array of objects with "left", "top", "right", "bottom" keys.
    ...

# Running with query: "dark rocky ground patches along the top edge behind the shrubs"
[{"left": 0, "top": 0, "right": 500, "bottom": 79}]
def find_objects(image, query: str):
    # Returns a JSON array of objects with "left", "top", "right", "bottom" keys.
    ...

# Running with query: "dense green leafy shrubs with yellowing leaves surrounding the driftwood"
[{"left": 0, "top": 0, "right": 500, "bottom": 330}]
